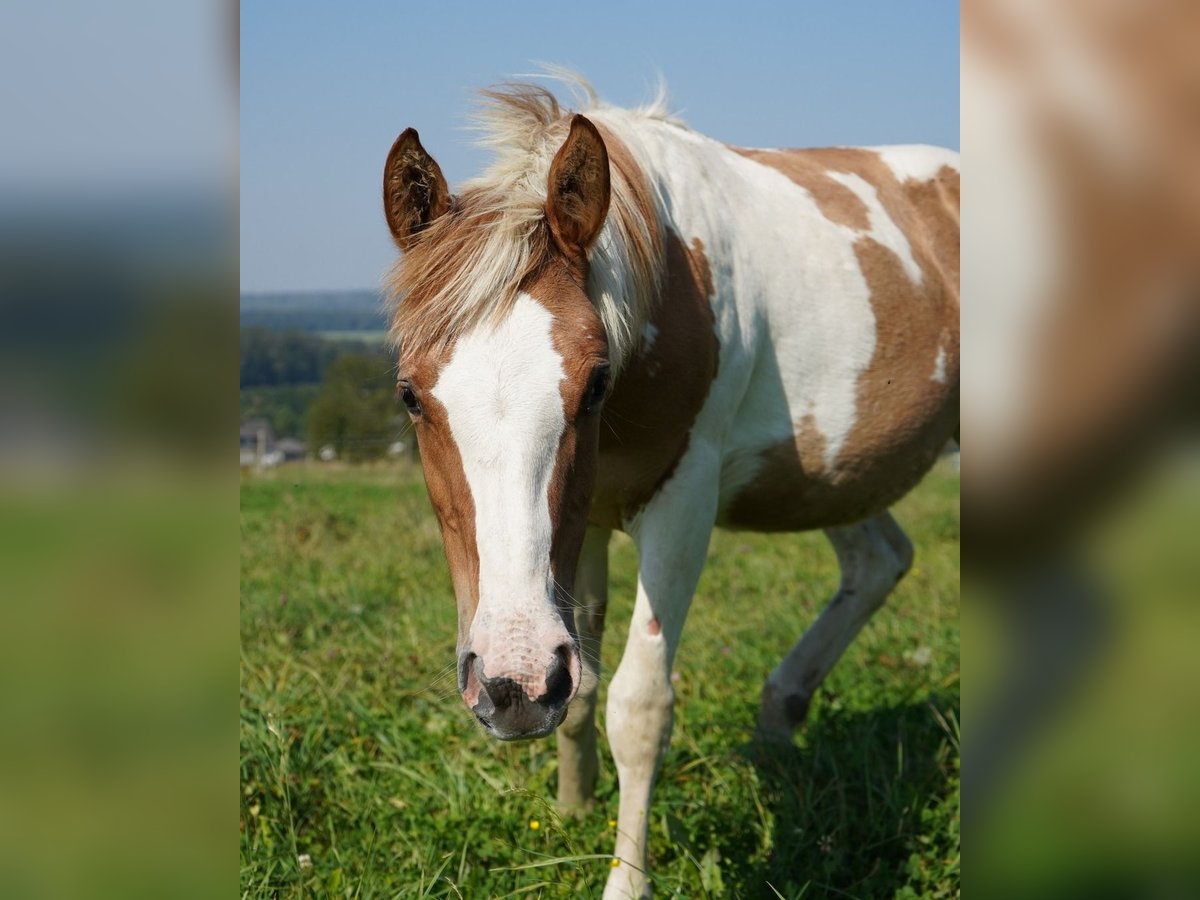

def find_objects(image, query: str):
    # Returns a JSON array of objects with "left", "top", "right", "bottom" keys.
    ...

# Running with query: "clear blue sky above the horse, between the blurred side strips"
[{"left": 240, "top": 0, "right": 959, "bottom": 290}]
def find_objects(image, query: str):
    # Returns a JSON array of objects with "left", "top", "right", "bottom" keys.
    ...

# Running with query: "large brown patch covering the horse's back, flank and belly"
[{"left": 721, "top": 149, "right": 959, "bottom": 530}]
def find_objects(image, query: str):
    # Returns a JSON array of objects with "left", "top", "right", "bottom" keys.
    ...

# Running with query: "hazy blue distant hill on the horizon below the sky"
[{"left": 241, "top": 290, "right": 388, "bottom": 334}]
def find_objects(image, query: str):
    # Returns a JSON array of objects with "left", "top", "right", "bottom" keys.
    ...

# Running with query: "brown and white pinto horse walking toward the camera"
[{"left": 383, "top": 79, "right": 959, "bottom": 899}]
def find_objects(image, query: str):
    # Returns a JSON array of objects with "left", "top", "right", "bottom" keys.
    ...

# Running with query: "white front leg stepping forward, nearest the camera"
[{"left": 604, "top": 448, "right": 718, "bottom": 900}]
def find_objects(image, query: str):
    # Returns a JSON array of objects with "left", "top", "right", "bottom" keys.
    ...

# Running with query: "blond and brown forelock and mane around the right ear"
[{"left": 386, "top": 72, "right": 668, "bottom": 370}]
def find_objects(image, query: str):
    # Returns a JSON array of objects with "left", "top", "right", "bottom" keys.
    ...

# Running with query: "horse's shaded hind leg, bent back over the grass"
[{"left": 758, "top": 512, "right": 912, "bottom": 742}]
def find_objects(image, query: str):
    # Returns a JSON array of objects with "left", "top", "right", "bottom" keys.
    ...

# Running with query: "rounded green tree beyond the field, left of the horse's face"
[{"left": 308, "top": 353, "right": 401, "bottom": 461}]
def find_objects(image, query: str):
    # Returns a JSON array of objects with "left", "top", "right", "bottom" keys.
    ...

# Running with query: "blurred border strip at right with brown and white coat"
[{"left": 961, "top": 0, "right": 1200, "bottom": 898}]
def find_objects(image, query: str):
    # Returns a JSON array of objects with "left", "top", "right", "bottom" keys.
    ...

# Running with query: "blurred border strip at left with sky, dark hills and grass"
[{"left": 0, "top": 0, "right": 238, "bottom": 898}]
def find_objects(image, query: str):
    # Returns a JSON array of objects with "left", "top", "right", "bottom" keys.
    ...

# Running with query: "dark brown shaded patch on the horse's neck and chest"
[{"left": 590, "top": 232, "right": 720, "bottom": 528}]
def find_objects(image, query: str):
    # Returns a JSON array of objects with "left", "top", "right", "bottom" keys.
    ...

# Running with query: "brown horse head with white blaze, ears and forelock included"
[{"left": 383, "top": 115, "right": 611, "bottom": 740}]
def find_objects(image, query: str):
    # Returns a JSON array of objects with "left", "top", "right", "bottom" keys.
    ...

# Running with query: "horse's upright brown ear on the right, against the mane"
[{"left": 546, "top": 115, "right": 610, "bottom": 259}]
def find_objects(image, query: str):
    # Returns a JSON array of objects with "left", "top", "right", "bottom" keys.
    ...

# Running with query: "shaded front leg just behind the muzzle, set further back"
[{"left": 557, "top": 528, "right": 612, "bottom": 812}]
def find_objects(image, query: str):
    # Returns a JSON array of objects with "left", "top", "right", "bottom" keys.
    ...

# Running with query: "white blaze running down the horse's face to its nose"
[{"left": 432, "top": 293, "right": 568, "bottom": 690}]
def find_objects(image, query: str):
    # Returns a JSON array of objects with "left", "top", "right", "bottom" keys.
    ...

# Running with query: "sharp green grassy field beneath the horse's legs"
[{"left": 240, "top": 464, "right": 959, "bottom": 898}]
